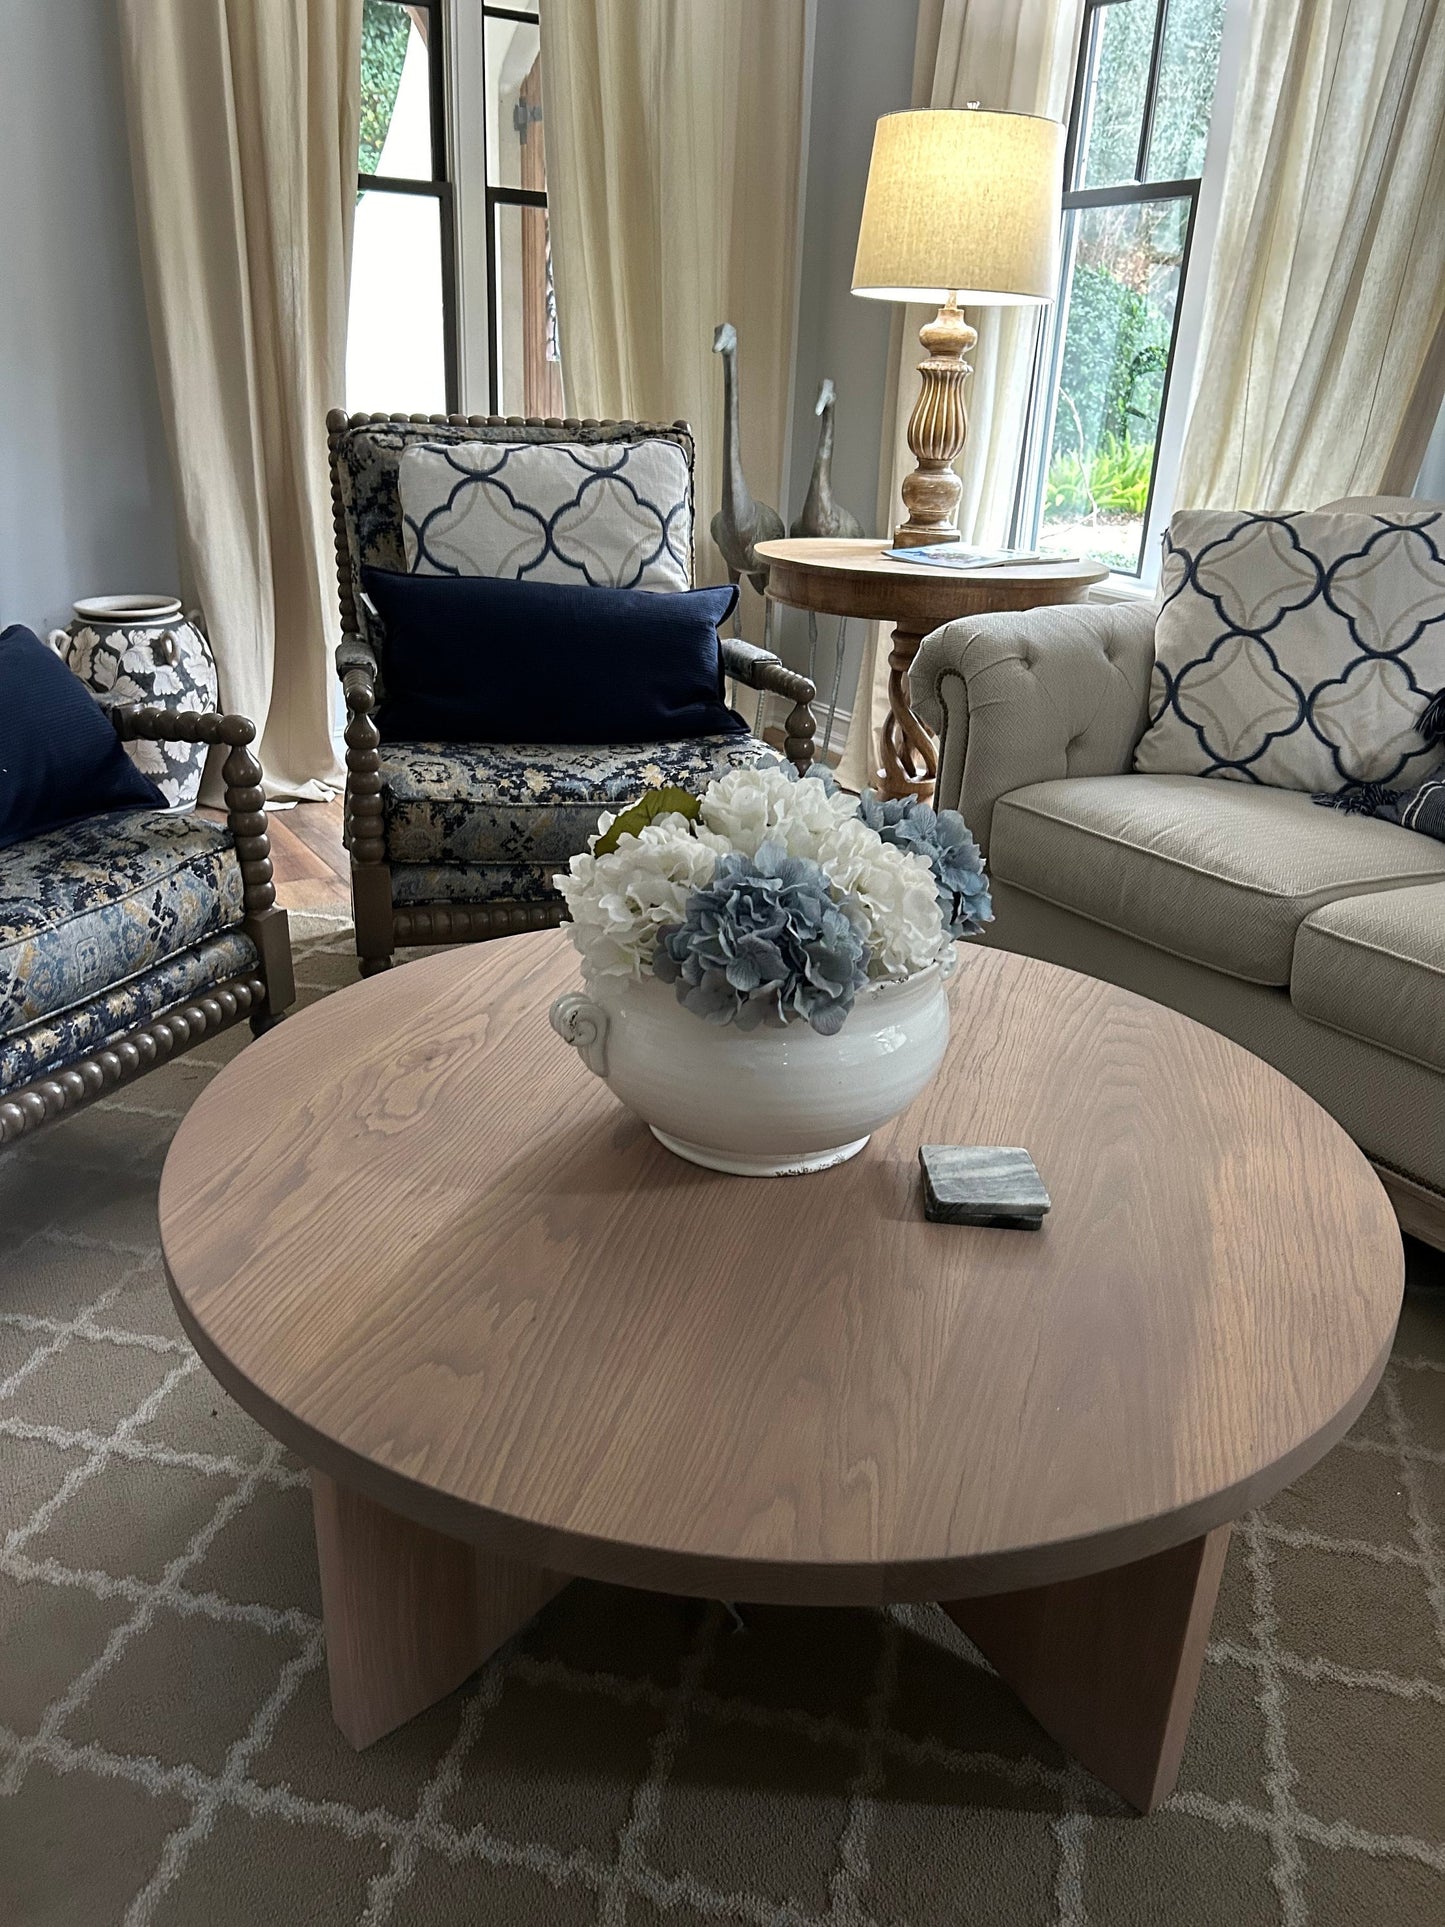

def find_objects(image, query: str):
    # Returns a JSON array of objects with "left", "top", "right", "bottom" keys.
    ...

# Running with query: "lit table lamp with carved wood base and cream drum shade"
[{"left": 854, "top": 108, "right": 1064, "bottom": 549}]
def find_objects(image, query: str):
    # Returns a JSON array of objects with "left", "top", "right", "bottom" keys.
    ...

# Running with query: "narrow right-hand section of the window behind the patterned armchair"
[{"left": 475, "top": 0, "right": 563, "bottom": 416}]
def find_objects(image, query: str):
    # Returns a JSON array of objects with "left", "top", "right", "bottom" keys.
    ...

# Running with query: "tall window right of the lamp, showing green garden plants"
[{"left": 1017, "top": 0, "right": 1231, "bottom": 576}]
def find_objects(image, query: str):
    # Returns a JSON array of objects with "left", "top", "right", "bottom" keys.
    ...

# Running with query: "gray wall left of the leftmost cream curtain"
[{"left": 0, "top": 0, "right": 177, "bottom": 626}]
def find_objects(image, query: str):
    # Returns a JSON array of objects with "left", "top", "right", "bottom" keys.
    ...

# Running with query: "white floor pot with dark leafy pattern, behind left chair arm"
[{"left": 50, "top": 595, "right": 220, "bottom": 809}]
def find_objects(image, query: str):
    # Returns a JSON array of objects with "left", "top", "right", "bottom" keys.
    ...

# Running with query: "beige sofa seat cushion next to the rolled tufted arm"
[{"left": 988, "top": 777, "right": 1445, "bottom": 985}]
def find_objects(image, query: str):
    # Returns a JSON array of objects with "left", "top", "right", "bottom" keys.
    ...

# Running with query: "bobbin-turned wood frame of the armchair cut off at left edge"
[{"left": 0, "top": 705, "right": 297, "bottom": 1145}]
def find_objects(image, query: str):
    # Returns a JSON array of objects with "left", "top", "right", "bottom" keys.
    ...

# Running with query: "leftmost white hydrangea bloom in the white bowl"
[{"left": 553, "top": 815, "right": 719, "bottom": 977}]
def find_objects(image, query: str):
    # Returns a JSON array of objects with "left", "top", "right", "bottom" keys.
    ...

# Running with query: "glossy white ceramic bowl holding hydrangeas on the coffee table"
[{"left": 551, "top": 946, "right": 958, "bottom": 1177}]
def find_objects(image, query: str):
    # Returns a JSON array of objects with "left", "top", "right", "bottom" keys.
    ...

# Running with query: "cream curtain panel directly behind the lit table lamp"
[{"left": 840, "top": 0, "right": 1083, "bottom": 788}]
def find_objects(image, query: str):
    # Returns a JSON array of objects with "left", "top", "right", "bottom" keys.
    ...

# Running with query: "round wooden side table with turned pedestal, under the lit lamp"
[{"left": 757, "top": 538, "right": 1108, "bottom": 802}]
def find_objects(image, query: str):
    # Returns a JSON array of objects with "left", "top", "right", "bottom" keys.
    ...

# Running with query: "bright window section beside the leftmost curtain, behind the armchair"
[{"left": 347, "top": 0, "right": 459, "bottom": 414}]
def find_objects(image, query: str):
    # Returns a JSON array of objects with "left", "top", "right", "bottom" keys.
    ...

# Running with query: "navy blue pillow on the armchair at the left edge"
[{"left": 0, "top": 622, "right": 166, "bottom": 850}]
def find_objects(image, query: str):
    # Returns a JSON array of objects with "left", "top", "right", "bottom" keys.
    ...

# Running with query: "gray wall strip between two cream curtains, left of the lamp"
[{"left": 780, "top": 0, "right": 919, "bottom": 744}]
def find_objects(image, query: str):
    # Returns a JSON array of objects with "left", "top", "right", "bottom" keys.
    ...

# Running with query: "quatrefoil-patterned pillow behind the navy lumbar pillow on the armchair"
[{"left": 397, "top": 441, "right": 692, "bottom": 590}]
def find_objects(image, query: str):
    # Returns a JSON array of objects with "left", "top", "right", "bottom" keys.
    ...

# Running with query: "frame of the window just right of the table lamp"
[{"left": 1010, "top": 0, "right": 1218, "bottom": 580}]
